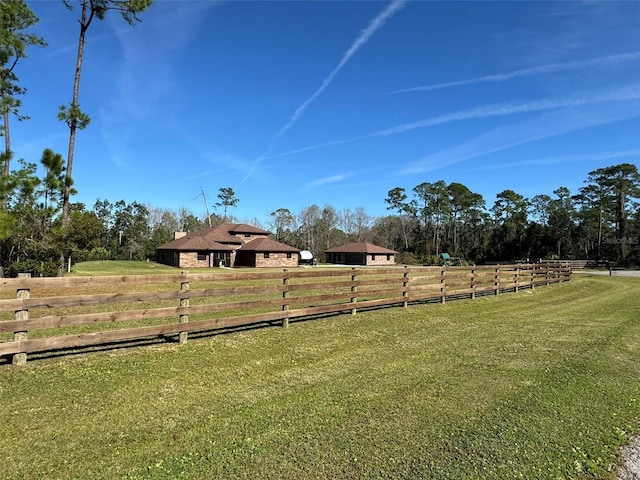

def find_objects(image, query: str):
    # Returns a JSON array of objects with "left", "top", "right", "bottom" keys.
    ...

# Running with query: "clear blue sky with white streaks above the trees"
[{"left": 12, "top": 0, "right": 640, "bottom": 224}]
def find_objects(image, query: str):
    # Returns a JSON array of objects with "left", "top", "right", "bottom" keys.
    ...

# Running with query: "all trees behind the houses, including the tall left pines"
[{"left": 0, "top": 0, "right": 640, "bottom": 276}]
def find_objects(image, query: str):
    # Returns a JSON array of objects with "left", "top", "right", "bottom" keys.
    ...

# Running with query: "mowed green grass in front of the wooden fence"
[{"left": 0, "top": 274, "right": 640, "bottom": 480}]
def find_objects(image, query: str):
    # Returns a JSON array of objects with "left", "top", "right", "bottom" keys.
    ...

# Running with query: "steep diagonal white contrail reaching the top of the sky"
[{"left": 242, "top": 0, "right": 407, "bottom": 183}]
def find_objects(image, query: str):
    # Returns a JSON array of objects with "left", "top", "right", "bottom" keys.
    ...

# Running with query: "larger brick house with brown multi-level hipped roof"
[{"left": 156, "top": 223, "right": 300, "bottom": 268}]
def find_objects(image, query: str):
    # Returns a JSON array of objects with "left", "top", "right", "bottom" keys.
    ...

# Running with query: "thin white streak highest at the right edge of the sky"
[{"left": 390, "top": 52, "right": 640, "bottom": 93}]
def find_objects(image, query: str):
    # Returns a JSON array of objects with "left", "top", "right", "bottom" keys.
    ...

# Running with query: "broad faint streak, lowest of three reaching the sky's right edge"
[{"left": 400, "top": 100, "right": 640, "bottom": 175}]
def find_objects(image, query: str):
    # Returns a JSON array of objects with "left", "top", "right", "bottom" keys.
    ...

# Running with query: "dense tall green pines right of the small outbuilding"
[{"left": 385, "top": 163, "right": 640, "bottom": 264}]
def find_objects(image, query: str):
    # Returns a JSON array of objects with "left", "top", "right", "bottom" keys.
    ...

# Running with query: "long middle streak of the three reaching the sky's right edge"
[{"left": 265, "top": 83, "right": 640, "bottom": 158}]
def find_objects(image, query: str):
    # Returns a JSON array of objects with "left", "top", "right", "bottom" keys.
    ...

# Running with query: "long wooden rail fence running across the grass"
[{"left": 0, "top": 262, "right": 571, "bottom": 365}]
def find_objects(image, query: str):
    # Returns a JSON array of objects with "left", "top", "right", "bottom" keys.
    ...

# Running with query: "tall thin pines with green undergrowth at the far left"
[{"left": 0, "top": 0, "right": 152, "bottom": 273}]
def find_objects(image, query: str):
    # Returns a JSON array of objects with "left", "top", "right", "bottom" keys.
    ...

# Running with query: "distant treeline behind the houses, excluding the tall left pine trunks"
[{"left": 0, "top": 158, "right": 640, "bottom": 276}]
